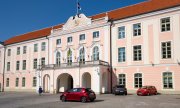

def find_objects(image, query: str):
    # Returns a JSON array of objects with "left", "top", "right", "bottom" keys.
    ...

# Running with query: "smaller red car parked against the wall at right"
[{"left": 137, "top": 86, "right": 157, "bottom": 96}]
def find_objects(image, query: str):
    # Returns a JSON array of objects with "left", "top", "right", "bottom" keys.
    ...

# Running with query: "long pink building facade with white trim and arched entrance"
[{"left": 0, "top": 0, "right": 180, "bottom": 94}]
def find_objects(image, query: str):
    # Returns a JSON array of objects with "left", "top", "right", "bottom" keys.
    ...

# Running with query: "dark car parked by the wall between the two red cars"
[{"left": 113, "top": 85, "right": 127, "bottom": 95}]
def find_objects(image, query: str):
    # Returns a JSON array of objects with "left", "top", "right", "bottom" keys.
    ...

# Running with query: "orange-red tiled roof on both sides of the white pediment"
[{"left": 5, "top": 0, "right": 180, "bottom": 45}]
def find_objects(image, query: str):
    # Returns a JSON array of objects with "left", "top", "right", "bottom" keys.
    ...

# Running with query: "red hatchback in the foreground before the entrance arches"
[{"left": 60, "top": 88, "right": 96, "bottom": 103}]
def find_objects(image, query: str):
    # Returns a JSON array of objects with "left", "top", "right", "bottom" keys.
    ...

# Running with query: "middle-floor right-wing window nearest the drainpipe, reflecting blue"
[{"left": 118, "top": 47, "right": 126, "bottom": 62}]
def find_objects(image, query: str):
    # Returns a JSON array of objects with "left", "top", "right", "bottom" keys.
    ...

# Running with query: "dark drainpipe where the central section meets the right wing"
[{"left": 108, "top": 19, "right": 113, "bottom": 93}]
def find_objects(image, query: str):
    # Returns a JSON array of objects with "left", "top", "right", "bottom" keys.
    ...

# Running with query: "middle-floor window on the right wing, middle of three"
[{"left": 133, "top": 45, "right": 142, "bottom": 61}]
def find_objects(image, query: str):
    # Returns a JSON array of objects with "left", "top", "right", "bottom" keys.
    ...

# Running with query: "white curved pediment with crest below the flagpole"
[{"left": 63, "top": 14, "right": 92, "bottom": 30}]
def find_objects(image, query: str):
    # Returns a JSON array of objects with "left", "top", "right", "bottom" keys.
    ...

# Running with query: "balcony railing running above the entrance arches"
[{"left": 39, "top": 60, "right": 109, "bottom": 70}]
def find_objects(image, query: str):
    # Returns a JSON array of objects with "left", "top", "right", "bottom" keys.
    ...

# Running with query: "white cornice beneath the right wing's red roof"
[{"left": 114, "top": 6, "right": 180, "bottom": 24}]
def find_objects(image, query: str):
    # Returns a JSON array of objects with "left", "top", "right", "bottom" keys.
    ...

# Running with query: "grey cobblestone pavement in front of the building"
[{"left": 0, "top": 92, "right": 180, "bottom": 108}]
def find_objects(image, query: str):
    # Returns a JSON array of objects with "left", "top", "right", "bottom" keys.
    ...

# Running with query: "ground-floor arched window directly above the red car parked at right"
[{"left": 134, "top": 73, "right": 142, "bottom": 88}]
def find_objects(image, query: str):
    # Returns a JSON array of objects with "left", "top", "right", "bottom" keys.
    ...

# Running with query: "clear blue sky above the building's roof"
[{"left": 0, "top": 0, "right": 145, "bottom": 41}]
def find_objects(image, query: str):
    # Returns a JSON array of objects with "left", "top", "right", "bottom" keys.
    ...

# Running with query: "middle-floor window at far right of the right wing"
[{"left": 161, "top": 42, "right": 171, "bottom": 59}]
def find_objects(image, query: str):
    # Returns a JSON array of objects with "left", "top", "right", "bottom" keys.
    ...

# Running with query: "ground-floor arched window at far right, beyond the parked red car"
[{"left": 163, "top": 72, "right": 173, "bottom": 89}]
